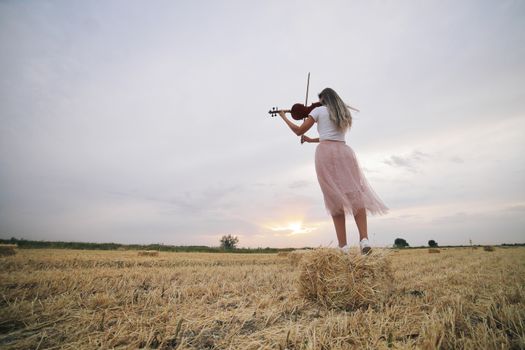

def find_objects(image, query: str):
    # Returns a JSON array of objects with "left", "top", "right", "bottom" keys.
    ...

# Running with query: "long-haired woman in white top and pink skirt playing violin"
[{"left": 279, "top": 88, "right": 388, "bottom": 254}]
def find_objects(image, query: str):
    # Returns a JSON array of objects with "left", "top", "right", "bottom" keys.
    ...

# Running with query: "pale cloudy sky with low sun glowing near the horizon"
[{"left": 0, "top": 0, "right": 525, "bottom": 247}]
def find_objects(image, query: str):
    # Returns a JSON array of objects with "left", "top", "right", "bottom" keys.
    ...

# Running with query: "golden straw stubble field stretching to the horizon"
[{"left": 0, "top": 248, "right": 525, "bottom": 349}]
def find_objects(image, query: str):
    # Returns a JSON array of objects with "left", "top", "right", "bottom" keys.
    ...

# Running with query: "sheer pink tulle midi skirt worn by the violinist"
[{"left": 315, "top": 141, "right": 388, "bottom": 215}]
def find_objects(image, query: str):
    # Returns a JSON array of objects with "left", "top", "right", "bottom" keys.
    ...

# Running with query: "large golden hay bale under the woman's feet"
[{"left": 298, "top": 248, "right": 393, "bottom": 310}]
